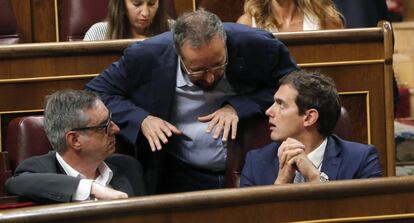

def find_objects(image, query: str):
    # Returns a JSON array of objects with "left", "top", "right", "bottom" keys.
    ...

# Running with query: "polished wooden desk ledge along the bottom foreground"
[{"left": 0, "top": 176, "right": 414, "bottom": 223}]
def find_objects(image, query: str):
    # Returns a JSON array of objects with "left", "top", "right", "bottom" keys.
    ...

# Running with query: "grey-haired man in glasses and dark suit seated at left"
[{"left": 5, "top": 90, "right": 145, "bottom": 202}]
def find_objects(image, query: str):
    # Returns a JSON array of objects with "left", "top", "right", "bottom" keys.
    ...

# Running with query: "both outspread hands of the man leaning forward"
[{"left": 141, "top": 104, "right": 239, "bottom": 152}]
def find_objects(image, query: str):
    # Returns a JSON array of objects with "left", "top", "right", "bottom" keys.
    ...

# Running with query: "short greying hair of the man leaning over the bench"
[{"left": 171, "top": 9, "right": 226, "bottom": 55}]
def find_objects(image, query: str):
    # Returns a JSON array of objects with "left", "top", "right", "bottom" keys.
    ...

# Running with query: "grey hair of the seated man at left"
[{"left": 43, "top": 89, "right": 100, "bottom": 152}]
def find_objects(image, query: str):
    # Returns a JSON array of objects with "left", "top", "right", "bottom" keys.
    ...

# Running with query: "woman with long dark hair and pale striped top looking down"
[{"left": 84, "top": 0, "right": 168, "bottom": 40}]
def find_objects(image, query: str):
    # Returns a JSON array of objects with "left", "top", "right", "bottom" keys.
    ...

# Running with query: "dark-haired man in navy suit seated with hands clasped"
[{"left": 240, "top": 71, "right": 381, "bottom": 187}]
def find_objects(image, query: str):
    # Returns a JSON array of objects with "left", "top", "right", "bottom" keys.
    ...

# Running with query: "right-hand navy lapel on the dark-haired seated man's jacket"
[{"left": 321, "top": 137, "right": 342, "bottom": 180}]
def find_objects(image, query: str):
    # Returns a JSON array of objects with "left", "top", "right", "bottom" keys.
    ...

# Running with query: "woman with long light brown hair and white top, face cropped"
[{"left": 237, "top": 0, "right": 343, "bottom": 32}]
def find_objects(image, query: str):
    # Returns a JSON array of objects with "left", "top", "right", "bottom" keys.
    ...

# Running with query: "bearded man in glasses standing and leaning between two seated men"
[{"left": 86, "top": 10, "right": 297, "bottom": 193}]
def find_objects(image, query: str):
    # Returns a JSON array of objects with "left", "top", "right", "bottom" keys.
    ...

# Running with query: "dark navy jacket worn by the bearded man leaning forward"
[{"left": 86, "top": 24, "right": 297, "bottom": 193}]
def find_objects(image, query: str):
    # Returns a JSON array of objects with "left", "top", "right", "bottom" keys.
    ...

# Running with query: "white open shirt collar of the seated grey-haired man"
[{"left": 56, "top": 153, "right": 113, "bottom": 186}]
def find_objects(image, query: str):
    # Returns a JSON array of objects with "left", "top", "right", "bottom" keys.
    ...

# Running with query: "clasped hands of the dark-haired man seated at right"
[{"left": 274, "top": 138, "right": 320, "bottom": 184}]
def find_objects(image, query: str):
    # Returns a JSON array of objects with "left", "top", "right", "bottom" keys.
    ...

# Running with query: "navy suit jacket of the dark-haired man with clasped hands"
[{"left": 240, "top": 135, "right": 381, "bottom": 187}]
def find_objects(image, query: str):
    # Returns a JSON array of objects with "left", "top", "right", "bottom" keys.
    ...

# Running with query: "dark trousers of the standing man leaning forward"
[{"left": 159, "top": 155, "right": 225, "bottom": 193}]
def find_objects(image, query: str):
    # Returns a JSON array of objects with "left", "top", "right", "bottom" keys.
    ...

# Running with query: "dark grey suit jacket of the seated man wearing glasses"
[{"left": 5, "top": 152, "right": 146, "bottom": 202}]
